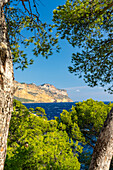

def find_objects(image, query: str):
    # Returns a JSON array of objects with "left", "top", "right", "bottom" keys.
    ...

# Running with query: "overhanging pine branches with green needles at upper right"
[{"left": 53, "top": 0, "right": 113, "bottom": 93}]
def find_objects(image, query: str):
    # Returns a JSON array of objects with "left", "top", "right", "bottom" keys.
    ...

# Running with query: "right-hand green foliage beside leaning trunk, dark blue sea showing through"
[{"left": 59, "top": 99, "right": 113, "bottom": 169}]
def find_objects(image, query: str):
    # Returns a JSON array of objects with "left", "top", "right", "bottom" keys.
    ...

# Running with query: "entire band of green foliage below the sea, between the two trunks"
[{"left": 5, "top": 99, "right": 113, "bottom": 170}]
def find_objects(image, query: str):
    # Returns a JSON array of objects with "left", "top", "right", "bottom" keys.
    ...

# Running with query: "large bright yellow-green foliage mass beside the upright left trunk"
[{"left": 5, "top": 100, "right": 81, "bottom": 170}]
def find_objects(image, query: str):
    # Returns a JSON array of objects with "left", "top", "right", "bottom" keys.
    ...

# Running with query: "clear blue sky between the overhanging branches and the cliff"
[{"left": 14, "top": 0, "right": 113, "bottom": 101}]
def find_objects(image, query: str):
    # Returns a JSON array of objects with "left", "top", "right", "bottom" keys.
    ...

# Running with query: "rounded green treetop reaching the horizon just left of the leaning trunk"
[{"left": 72, "top": 99, "right": 113, "bottom": 138}]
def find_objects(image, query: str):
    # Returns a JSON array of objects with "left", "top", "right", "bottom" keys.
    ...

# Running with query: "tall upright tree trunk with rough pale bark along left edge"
[{"left": 0, "top": 0, "right": 13, "bottom": 170}]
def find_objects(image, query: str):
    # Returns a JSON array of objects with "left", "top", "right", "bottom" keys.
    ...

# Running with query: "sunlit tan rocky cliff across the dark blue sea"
[{"left": 14, "top": 81, "right": 73, "bottom": 103}]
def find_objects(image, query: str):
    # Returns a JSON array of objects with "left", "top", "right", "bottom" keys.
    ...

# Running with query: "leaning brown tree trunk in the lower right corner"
[{"left": 89, "top": 108, "right": 113, "bottom": 170}]
